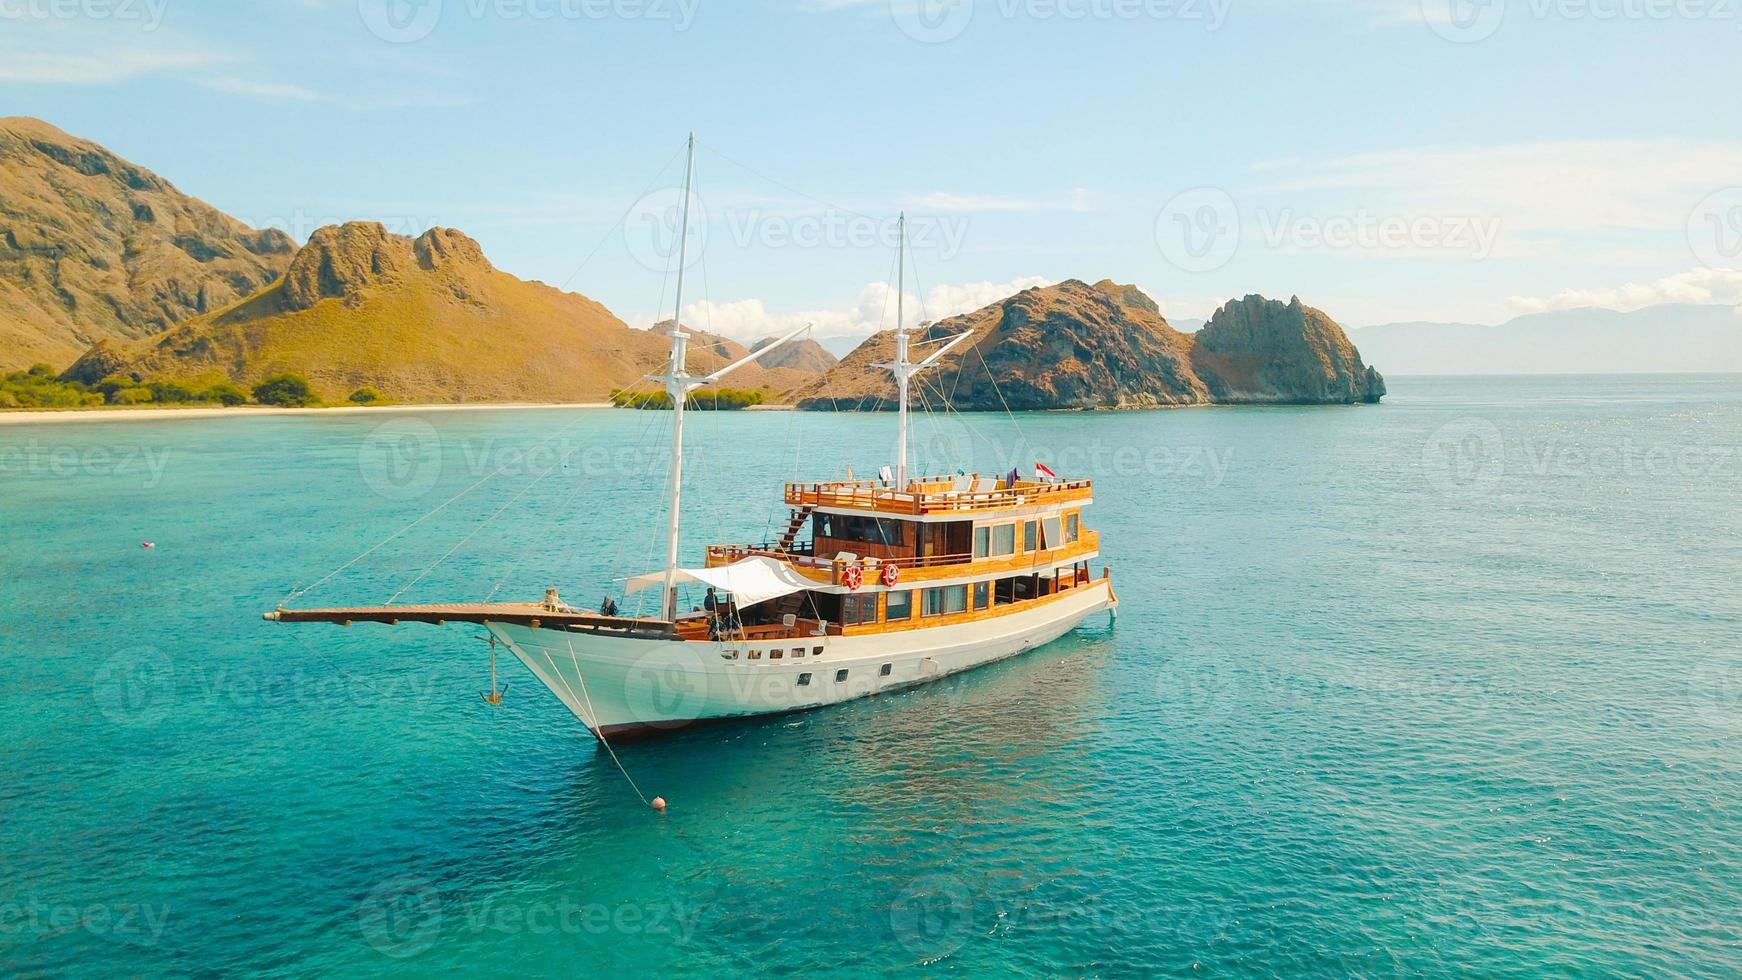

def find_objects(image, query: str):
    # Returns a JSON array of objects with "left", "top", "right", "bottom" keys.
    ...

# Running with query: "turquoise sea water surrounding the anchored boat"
[{"left": 0, "top": 378, "right": 1742, "bottom": 977}]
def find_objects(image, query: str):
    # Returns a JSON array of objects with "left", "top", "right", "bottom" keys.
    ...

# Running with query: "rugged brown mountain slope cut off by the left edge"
[{"left": 0, "top": 117, "right": 296, "bottom": 371}]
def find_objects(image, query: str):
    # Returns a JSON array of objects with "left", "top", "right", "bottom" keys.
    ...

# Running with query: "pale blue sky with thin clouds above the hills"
[{"left": 0, "top": 0, "right": 1742, "bottom": 338}]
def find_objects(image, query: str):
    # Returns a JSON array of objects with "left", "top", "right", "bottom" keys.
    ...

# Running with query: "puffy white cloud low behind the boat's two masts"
[{"left": 661, "top": 275, "right": 1050, "bottom": 343}]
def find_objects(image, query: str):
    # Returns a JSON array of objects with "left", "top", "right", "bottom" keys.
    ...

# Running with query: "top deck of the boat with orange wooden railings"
[{"left": 786, "top": 475, "right": 1094, "bottom": 517}]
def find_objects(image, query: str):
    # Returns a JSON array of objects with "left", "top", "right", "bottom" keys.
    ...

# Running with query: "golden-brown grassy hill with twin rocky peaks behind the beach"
[{"left": 66, "top": 223, "right": 822, "bottom": 402}]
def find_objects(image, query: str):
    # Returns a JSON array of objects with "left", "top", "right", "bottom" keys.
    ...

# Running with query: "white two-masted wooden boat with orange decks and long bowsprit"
[{"left": 265, "top": 136, "right": 1118, "bottom": 740}]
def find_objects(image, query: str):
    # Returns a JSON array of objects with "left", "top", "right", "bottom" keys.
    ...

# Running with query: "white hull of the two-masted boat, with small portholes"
[{"left": 488, "top": 578, "right": 1117, "bottom": 738}]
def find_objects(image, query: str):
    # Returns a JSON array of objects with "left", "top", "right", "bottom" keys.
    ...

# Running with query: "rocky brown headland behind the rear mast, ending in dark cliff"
[{"left": 796, "top": 279, "right": 1385, "bottom": 411}]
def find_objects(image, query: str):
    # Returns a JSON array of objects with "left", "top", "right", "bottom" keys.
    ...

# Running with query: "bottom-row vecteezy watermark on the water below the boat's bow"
[{"left": 357, "top": 877, "right": 706, "bottom": 959}]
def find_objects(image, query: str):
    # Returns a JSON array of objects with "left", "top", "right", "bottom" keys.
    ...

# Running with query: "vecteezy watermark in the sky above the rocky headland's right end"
[{"left": 1155, "top": 186, "right": 1502, "bottom": 272}]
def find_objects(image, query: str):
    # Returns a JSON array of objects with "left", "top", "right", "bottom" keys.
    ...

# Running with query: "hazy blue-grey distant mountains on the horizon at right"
[{"left": 1350, "top": 303, "right": 1742, "bottom": 376}]
